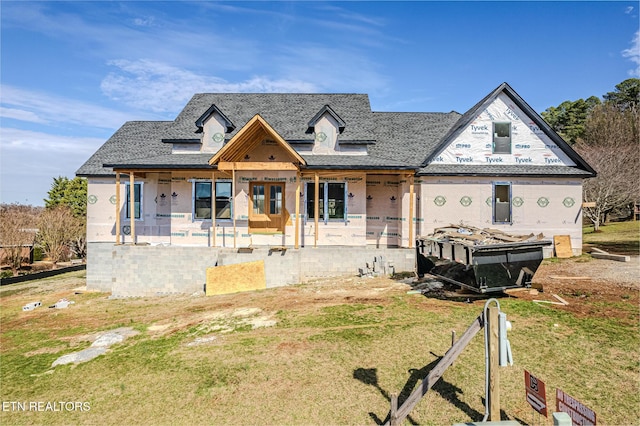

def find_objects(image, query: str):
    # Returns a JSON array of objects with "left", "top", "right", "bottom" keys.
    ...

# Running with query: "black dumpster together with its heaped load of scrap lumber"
[{"left": 416, "top": 227, "right": 551, "bottom": 293}]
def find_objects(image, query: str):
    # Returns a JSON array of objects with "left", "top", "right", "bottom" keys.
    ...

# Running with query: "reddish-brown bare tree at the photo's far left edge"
[{"left": 0, "top": 204, "right": 42, "bottom": 275}]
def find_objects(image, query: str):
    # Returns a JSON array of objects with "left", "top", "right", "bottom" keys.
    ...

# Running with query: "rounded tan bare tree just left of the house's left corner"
[{"left": 38, "top": 206, "right": 84, "bottom": 264}]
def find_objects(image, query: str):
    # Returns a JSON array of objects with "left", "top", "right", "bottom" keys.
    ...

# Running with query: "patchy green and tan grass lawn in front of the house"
[{"left": 0, "top": 264, "right": 640, "bottom": 425}]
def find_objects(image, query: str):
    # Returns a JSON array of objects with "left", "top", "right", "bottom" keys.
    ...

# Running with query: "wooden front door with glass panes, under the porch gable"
[{"left": 249, "top": 182, "right": 284, "bottom": 233}]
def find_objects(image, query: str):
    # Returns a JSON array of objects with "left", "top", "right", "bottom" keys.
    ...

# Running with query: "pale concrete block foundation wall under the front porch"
[{"left": 87, "top": 243, "right": 415, "bottom": 297}]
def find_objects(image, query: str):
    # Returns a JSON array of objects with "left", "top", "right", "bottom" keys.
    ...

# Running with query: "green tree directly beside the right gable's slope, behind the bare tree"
[{"left": 542, "top": 96, "right": 601, "bottom": 144}]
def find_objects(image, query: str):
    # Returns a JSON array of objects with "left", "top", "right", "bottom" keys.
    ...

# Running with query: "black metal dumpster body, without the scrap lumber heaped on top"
[{"left": 416, "top": 240, "right": 551, "bottom": 293}]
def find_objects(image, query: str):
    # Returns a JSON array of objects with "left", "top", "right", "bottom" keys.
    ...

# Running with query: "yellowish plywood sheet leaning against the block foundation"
[{"left": 206, "top": 260, "right": 267, "bottom": 296}]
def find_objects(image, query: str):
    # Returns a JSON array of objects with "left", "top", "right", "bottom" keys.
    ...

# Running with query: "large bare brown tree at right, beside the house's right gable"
[{"left": 574, "top": 103, "right": 640, "bottom": 230}]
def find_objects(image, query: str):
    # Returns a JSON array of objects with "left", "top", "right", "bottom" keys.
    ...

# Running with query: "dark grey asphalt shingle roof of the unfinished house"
[{"left": 76, "top": 83, "right": 594, "bottom": 177}]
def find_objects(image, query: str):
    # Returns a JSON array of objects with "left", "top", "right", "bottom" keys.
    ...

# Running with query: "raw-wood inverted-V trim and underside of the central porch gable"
[{"left": 209, "top": 114, "right": 306, "bottom": 169}]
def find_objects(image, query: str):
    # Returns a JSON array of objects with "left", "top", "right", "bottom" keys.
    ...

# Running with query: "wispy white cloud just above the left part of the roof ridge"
[{"left": 101, "top": 59, "right": 317, "bottom": 112}]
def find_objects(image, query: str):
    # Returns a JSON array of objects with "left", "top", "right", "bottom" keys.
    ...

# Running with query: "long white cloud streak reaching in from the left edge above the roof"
[{"left": 0, "top": 85, "right": 144, "bottom": 129}]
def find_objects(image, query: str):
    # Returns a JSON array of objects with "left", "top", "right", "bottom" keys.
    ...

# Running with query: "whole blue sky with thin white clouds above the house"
[{"left": 0, "top": 0, "right": 640, "bottom": 205}]
